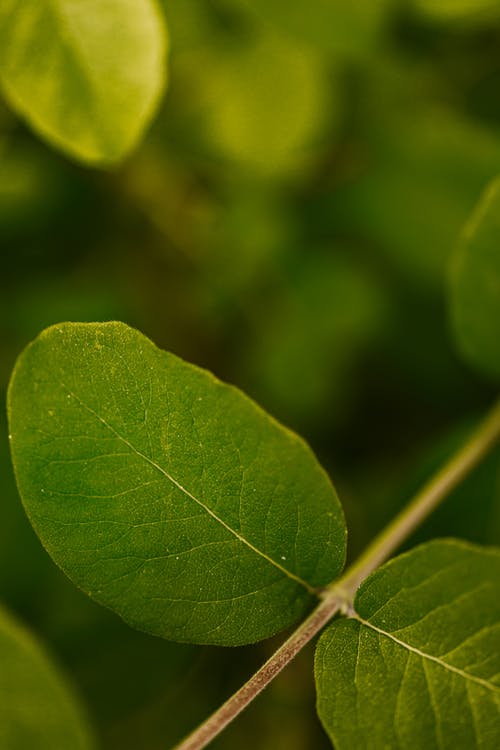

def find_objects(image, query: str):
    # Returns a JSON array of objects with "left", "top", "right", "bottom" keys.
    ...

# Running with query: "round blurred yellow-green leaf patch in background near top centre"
[{"left": 191, "top": 29, "right": 332, "bottom": 176}]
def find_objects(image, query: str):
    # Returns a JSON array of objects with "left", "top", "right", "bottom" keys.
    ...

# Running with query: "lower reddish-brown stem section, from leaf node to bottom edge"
[{"left": 175, "top": 596, "right": 340, "bottom": 750}]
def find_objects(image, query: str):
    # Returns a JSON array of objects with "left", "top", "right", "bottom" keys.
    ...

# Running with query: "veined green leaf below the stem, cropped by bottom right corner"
[{"left": 315, "top": 540, "right": 500, "bottom": 750}]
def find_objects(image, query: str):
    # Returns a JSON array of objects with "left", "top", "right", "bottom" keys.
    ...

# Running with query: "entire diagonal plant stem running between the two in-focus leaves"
[{"left": 175, "top": 400, "right": 500, "bottom": 750}]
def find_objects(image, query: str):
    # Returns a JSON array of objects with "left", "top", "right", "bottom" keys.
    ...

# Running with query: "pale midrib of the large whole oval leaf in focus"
[{"left": 63, "top": 384, "right": 318, "bottom": 596}]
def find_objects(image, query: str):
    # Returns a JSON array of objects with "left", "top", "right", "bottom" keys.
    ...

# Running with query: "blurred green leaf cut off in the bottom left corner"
[{"left": 0, "top": 607, "right": 94, "bottom": 750}]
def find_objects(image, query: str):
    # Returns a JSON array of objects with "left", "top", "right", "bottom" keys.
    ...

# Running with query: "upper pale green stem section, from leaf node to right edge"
[{"left": 330, "top": 400, "right": 500, "bottom": 598}]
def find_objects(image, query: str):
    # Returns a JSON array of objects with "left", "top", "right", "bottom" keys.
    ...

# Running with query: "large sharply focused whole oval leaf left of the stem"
[{"left": 9, "top": 323, "right": 346, "bottom": 645}]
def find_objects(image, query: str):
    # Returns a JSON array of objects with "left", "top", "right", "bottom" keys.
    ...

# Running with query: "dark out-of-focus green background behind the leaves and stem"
[{"left": 0, "top": 0, "right": 500, "bottom": 750}]
